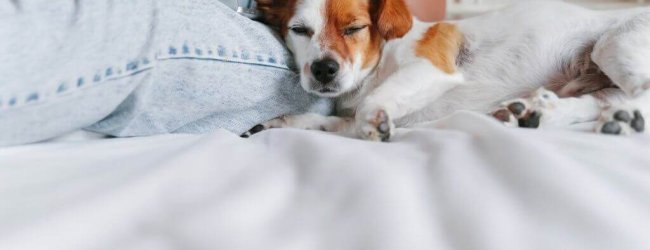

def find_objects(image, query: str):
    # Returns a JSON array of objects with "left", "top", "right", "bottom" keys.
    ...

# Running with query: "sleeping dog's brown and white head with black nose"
[{"left": 257, "top": 0, "right": 413, "bottom": 97}]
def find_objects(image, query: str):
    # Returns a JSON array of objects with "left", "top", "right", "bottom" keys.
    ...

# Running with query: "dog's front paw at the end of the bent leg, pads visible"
[{"left": 358, "top": 109, "right": 395, "bottom": 142}]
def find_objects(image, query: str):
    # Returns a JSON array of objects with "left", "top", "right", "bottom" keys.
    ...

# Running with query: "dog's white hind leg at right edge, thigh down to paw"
[{"left": 591, "top": 13, "right": 650, "bottom": 134}]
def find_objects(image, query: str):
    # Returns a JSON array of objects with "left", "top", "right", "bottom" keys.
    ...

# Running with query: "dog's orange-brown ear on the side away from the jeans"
[{"left": 370, "top": 0, "right": 413, "bottom": 40}]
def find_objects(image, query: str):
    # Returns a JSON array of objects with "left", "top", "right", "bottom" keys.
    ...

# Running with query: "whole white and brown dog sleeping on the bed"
[{"left": 249, "top": 0, "right": 650, "bottom": 141}]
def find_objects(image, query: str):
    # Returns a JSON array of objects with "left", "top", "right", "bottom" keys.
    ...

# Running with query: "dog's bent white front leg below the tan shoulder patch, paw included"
[{"left": 355, "top": 59, "right": 464, "bottom": 141}]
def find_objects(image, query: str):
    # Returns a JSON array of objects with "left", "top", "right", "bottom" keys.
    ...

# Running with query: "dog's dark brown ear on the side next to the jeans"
[{"left": 256, "top": 0, "right": 295, "bottom": 35}]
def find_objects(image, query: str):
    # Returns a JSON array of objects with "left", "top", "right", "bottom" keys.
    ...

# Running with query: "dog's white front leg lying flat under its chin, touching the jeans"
[{"left": 241, "top": 113, "right": 353, "bottom": 137}]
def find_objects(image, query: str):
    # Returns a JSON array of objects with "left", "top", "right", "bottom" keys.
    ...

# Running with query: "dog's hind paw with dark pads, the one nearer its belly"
[{"left": 491, "top": 88, "right": 559, "bottom": 128}]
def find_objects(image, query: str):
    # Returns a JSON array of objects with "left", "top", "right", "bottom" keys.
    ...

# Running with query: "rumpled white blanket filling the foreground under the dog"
[{"left": 0, "top": 113, "right": 650, "bottom": 250}]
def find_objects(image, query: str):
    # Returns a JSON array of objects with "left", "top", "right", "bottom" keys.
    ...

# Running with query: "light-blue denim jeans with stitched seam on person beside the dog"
[{"left": 0, "top": 0, "right": 331, "bottom": 145}]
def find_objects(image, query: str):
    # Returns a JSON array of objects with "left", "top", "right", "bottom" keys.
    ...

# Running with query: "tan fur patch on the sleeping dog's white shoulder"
[{"left": 415, "top": 23, "right": 463, "bottom": 74}]
